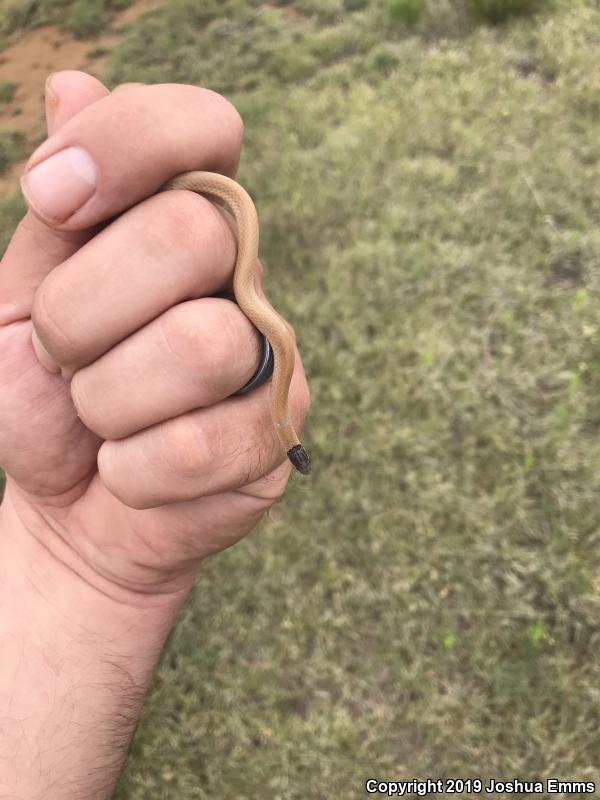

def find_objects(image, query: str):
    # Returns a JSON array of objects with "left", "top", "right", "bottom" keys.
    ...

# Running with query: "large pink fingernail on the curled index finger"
[{"left": 21, "top": 147, "right": 98, "bottom": 222}]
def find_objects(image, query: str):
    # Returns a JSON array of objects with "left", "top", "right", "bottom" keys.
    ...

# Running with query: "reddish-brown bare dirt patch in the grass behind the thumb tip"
[{"left": 0, "top": 0, "right": 164, "bottom": 193}]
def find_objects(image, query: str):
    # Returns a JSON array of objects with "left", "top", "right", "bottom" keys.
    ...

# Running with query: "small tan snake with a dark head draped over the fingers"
[{"left": 161, "top": 172, "right": 310, "bottom": 475}]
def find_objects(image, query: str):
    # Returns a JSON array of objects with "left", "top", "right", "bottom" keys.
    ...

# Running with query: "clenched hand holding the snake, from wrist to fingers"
[{"left": 0, "top": 72, "right": 309, "bottom": 594}]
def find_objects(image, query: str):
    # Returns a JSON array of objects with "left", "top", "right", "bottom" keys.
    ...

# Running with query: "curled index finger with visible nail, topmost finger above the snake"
[{"left": 21, "top": 84, "right": 243, "bottom": 230}]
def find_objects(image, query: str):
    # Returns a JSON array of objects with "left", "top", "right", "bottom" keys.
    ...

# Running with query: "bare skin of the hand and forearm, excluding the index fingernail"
[{"left": 0, "top": 71, "right": 309, "bottom": 800}]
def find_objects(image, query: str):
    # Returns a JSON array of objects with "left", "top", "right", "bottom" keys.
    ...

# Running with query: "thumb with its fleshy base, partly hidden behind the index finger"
[{"left": 0, "top": 71, "right": 109, "bottom": 496}]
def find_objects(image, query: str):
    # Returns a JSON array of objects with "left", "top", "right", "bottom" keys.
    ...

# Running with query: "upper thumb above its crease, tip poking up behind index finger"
[{"left": 0, "top": 70, "right": 110, "bottom": 325}]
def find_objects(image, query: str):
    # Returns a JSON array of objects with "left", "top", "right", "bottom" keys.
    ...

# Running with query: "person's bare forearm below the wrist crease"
[{"left": 0, "top": 488, "right": 192, "bottom": 800}]
